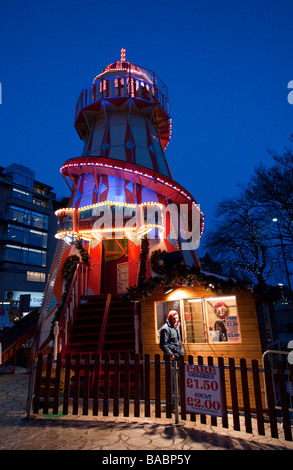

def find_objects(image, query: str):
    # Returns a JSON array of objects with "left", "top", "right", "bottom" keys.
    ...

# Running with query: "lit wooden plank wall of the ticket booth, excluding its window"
[{"left": 141, "top": 286, "right": 264, "bottom": 408}]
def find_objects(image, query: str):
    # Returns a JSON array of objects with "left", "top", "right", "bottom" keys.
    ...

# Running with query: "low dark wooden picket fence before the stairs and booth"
[{"left": 27, "top": 353, "right": 293, "bottom": 441}]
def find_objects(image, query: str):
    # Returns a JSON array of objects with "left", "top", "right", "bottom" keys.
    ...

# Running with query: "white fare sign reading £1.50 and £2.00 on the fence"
[{"left": 185, "top": 364, "right": 222, "bottom": 416}]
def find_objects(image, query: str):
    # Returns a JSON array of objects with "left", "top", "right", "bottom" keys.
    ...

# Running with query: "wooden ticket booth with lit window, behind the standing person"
[{"left": 141, "top": 286, "right": 263, "bottom": 408}]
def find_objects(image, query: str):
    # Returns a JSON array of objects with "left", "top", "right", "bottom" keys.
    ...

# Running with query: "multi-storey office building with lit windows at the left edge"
[{"left": 0, "top": 164, "right": 57, "bottom": 310}]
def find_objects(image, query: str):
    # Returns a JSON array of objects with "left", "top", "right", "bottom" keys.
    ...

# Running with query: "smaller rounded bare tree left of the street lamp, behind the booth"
[{"left": 205, "top": 194, "right": 276, "bottom": 286}]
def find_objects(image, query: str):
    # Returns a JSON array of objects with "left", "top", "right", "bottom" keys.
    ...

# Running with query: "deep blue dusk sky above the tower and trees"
[{"left": 0, "top": 0, "right": 293, "bottom": 253}]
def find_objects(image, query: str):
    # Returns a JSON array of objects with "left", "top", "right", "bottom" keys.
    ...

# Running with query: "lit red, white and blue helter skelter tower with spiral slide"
[{"left": 34, "top": 49, "right": 203, "bottom": 347}]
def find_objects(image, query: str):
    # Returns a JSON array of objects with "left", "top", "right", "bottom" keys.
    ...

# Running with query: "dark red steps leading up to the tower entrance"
[{"left": 63, "top": 295, "right": 135, "bottom": 395}]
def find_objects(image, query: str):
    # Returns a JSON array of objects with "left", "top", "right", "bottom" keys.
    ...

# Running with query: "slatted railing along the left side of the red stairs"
[{"left": 54, "top": 263, "right": 88, "bottom": 357}]
